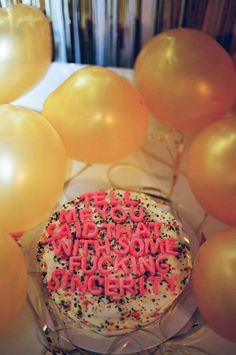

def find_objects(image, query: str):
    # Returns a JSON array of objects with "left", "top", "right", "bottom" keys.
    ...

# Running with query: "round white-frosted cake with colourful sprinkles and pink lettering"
[{"left": 37, "top": 189, "right": 192, "bottom": 335}]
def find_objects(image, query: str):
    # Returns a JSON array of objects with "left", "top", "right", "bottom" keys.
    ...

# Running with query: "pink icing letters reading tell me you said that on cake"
[{"left": 44, "top": 190, "right": 179, "bottom": 297}]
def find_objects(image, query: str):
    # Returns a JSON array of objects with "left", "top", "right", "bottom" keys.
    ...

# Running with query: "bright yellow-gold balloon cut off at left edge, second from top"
[{"left": 0, "top": 105, "right": 66, "bottom": 233}]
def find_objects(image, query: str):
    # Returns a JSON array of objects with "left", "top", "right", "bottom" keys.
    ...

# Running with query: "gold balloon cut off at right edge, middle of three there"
[{"left": 187, "top": 116, "right": 236, "bottom": 225}]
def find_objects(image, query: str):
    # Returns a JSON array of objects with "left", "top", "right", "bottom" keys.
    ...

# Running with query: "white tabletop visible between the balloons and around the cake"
[{"left": 0, "top": 63, "right": 236, "bottom": 355}]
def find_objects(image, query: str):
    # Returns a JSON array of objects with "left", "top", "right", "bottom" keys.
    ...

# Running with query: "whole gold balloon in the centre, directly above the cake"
[{"left": 42, "top": 67, "right": 148, "bottom": 163}]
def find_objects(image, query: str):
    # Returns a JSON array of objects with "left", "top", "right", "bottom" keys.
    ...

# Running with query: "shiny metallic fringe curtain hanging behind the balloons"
[{"left": 0, "top": 0, "right": 236, "bottom": 67}]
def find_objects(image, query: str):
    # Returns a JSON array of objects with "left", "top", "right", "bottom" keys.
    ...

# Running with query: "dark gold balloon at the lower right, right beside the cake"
[{"left": 192, "top": 229, "right": 236, "bottom": 342}]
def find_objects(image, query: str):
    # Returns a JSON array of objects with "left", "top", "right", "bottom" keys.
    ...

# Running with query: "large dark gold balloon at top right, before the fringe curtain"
[{"left": 135, "top": 29, "right": 236, "bottom": 132}]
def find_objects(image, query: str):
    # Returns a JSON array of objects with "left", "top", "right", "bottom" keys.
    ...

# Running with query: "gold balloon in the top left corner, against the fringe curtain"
[{"left": 0, "top": 5, "right": 52, "bottom": 103}]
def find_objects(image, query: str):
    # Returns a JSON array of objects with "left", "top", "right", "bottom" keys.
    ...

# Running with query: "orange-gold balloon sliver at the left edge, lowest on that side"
[{"left": 0, "top": 233, "right": 27, "bottom": 335}]
